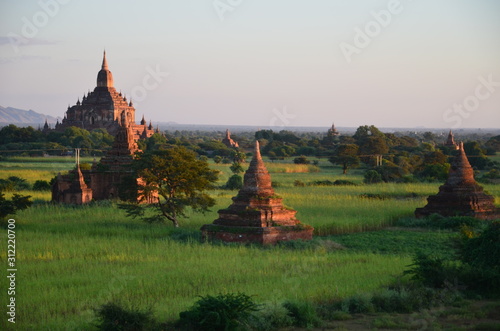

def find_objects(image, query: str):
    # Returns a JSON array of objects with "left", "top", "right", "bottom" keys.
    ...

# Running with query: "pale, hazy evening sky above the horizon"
[{"left": 0, "top": 0, "right": 500, "bottom": 129}]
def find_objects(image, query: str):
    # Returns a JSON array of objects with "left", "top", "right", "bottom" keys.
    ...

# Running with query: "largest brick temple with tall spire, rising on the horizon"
[{"left": 55, "top": 52, "right": 155, "bottom": 140}]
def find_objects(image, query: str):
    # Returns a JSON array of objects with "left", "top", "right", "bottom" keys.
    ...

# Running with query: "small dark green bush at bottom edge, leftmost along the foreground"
[{"left": 94, "top": 302, "right": 156, "bottom": 331}]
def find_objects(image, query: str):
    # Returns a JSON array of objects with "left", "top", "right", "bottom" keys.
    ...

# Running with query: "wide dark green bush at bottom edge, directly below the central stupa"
[{"left": 178, "top": 293, "right": 261, "bottom": 331}]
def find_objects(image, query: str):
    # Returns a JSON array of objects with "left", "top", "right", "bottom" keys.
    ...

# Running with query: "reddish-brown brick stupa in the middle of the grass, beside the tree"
[{"left": 201, "top": 141, "right": 313, "bottom": 244}]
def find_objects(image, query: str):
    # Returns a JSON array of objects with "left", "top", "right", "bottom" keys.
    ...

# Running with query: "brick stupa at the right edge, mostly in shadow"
[{"left": 415, "top": 143, "right": 500, "bottom": 219}]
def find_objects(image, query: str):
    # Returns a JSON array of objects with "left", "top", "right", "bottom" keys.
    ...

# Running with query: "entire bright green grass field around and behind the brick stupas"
[{"left": 0, "top": 158, "right": 500, "bottom": 330}]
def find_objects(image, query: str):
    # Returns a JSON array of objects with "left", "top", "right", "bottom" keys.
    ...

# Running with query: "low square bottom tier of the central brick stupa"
[{"left": 201, "top": 224, "right": 314, "bottom": 245}]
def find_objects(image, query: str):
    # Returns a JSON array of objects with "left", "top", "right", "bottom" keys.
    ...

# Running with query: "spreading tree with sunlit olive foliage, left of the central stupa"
[{"left": 120, "top": 146, "right": 217, "bottom": 227}]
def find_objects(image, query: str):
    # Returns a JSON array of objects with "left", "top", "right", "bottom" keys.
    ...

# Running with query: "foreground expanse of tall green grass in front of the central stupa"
[{"left": 0, "top": 205, "right": 410, "bottom": 329}]
